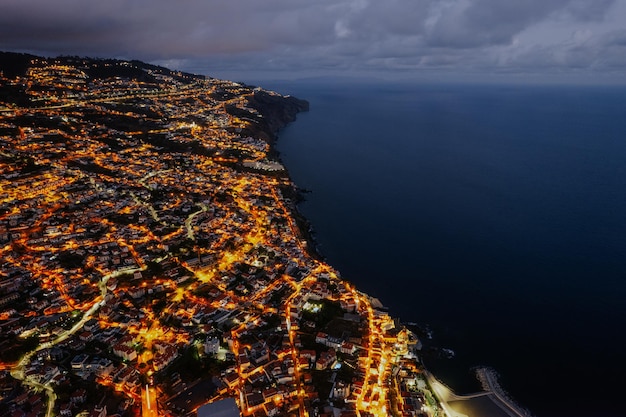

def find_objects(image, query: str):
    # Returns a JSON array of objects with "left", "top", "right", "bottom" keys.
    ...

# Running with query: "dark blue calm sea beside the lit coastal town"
[{"left": 263, "top": 81, "right": 626, "bottom": 417}]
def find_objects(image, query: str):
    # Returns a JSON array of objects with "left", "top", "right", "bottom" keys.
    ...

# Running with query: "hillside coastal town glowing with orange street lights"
[{"left": 0, "top": 53, "right": 448, "bottom": 417}]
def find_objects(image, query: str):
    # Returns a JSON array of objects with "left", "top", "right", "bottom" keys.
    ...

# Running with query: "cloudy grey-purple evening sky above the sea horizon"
[{"left": 0, "top": 0, "right": 626, "bottom": 83}]
